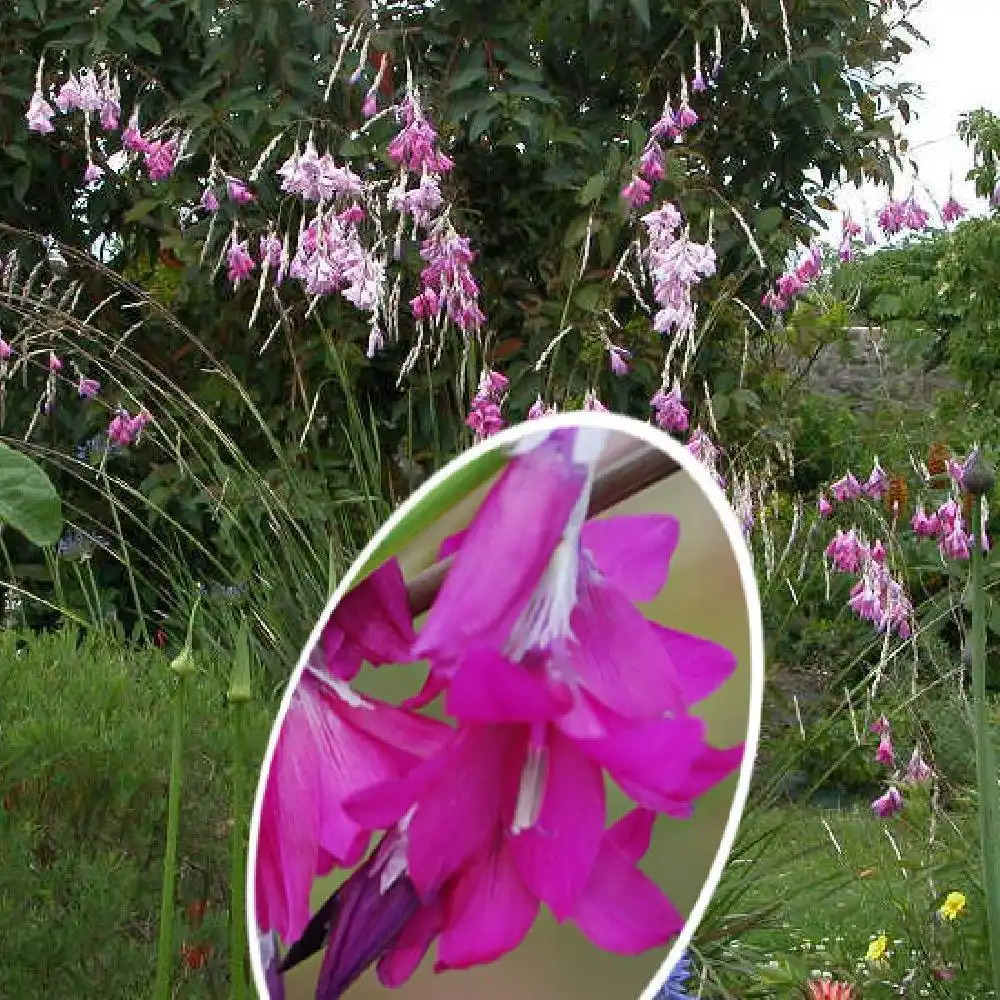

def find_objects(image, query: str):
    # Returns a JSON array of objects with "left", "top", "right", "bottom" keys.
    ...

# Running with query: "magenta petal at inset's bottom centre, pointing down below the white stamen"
[{"left": 434, "top": 833, "right": 538, "bottom": 972}]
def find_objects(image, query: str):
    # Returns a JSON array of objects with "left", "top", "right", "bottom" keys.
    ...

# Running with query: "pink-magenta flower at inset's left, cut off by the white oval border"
[{"left": 256, "top": 668, "right": 451, "bottom": 941}]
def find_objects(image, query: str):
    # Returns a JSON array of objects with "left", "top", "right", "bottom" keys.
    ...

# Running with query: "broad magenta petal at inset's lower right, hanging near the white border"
[{"left": 572, "top": 816, "right": 684, "bottom": 955}]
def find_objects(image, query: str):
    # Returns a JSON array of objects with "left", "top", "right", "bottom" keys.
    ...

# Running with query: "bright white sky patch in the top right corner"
[{"left": 833, "top": 0, "right": 1000, "bottom": 238}]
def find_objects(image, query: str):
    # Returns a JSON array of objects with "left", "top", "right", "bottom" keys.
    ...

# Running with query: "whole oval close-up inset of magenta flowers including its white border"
[{"left": 248, "top": 413, "right": 763, "bottom": 1000}]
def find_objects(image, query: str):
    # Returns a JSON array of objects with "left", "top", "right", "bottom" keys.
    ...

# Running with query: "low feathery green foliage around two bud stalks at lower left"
[{"left": 0, "top": 631, "right": 273, "bottom": 1000}]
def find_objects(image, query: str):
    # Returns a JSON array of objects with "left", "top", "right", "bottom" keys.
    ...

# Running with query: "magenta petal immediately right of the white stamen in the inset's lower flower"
[{"left": 510, "top": 729, "right": 605, "bottom": 920}]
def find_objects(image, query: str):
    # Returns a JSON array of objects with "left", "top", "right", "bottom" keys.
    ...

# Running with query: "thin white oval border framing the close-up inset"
[{"left": 246, "top": 410, "right": 764, "bottom": 1000}]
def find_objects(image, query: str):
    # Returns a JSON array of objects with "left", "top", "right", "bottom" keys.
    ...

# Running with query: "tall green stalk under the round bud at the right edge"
[{"left": 971, "top": 494, "right": 1000, "bottom": 996}]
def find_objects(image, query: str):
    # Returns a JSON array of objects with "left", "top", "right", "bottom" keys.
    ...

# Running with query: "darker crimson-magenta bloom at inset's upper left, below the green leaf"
[{"left": 322, "top": 559, "right": 416, "bottom": 681}]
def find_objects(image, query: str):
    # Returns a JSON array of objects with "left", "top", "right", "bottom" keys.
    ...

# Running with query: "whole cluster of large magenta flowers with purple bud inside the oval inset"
[{"left": 255, "top": 427, "right": 743, "bottom": 1000}]
